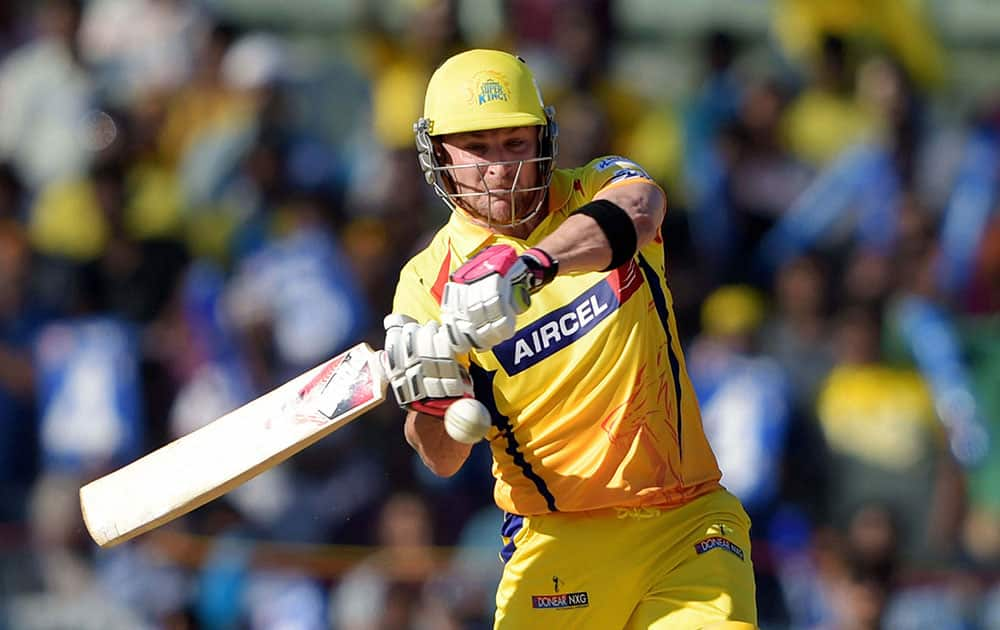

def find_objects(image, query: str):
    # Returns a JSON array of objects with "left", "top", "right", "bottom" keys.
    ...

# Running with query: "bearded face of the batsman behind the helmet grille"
[{"left": 442, "top": 127, "right": 542, "bottom": 225}]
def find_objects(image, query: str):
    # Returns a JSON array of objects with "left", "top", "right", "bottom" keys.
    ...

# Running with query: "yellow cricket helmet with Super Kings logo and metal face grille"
[{"left": 413, "top": 49, "right": 559, "bottom": 226}]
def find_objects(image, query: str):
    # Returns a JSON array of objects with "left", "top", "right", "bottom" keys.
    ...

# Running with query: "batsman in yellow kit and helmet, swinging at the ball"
[{"left": 385, "top": 50, "right": 757, "bottom": 630}]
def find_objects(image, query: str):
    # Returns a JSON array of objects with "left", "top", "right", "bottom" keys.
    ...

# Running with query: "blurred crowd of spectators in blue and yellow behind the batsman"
[{"left": 0, "top": 0, "right": 1000, "bottom": 630}]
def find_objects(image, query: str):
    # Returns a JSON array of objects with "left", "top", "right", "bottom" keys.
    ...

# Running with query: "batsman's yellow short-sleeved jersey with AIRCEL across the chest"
[{"left": 393, "top": 156, "right": 721, "bottom": 515}]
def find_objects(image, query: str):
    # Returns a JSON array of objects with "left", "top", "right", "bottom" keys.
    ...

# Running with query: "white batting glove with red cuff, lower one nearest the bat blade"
[{"left": 382, "top": 313, "right": 472, "bottom": 416}]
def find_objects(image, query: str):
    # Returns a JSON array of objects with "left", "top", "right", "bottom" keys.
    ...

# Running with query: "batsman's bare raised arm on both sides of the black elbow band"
[{"left": 538, "top": 182, "right": 666, "bottom": 273}]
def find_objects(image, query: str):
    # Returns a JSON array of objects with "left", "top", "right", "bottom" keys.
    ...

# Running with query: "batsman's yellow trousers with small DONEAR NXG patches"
[{"left": 495, "top": 490, "right": 757, "bottom": 630}]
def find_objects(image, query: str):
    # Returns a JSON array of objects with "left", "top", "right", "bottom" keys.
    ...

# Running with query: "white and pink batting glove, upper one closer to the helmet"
[{"left": 441, "top": 245, "right": 559, "bottom": 352}]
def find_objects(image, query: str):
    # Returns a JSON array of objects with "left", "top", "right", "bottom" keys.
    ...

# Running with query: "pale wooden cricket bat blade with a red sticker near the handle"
[{"left": 80, "top": 343, "right": 387, "bottom": 547}]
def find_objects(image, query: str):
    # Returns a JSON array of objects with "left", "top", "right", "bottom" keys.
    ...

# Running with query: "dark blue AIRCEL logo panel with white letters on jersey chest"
[{"left": 493, "top": 280, "right": 619, "bottom": 376}]
